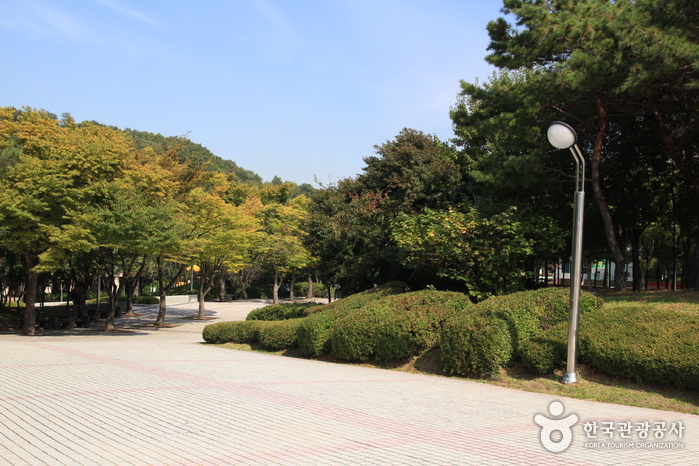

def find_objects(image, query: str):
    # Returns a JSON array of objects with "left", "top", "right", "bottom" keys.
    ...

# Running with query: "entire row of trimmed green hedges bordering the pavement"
[{"left": 204, "top": 283, "right": 699, "bottom": 390}]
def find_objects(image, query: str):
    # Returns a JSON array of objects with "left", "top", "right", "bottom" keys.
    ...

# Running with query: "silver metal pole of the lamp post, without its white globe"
[{"left": 562, "top": 145, "right": 585, "bottom": 384}]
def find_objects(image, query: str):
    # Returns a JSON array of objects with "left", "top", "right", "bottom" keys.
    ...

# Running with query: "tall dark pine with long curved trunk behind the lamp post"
[{"left": 487, "top": 0, "right": 699, "bottom": 290}]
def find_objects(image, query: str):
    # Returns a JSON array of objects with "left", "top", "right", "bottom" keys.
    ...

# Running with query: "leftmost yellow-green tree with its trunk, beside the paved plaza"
[{"left": 0, "top": 108, "right": 130, "bottom": 335}]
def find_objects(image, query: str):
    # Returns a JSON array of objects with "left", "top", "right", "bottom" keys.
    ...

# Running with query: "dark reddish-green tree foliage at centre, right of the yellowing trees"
[{"left": 306, "top": 129, "right": 461, "bottom": 293}]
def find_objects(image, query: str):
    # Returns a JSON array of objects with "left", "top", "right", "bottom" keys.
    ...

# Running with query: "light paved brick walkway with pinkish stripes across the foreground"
[{"left": 0, "top": 301, "right": 699, "bottom": 466}]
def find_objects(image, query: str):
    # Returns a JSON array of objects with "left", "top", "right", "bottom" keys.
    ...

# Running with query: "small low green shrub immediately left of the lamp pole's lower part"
[{"left": 520, "top": 322, "right": 568, "bottom": 374}]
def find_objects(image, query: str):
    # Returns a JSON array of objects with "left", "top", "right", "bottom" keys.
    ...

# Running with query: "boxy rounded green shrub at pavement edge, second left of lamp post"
[{"left": 441, "top": 312, "right": 512, "bottom": 375}]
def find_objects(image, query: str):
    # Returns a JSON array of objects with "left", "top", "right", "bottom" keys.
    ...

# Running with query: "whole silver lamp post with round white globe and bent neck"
[{"left": 546, "top": 121, "right": 585, "bottom": 384}]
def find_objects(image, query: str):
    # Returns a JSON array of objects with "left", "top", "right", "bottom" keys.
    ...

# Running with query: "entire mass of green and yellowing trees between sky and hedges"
[{"left": 0, "top": 0, "right": 699, "bottom": 334}]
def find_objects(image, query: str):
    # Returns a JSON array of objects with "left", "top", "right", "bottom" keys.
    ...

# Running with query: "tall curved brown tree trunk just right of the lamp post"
[{"left": 590, "top": 95, "right": 626, "bottom": 291}]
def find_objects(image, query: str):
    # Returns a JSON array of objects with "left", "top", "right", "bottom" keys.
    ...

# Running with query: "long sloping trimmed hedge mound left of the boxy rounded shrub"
[{"left": 331, "top": 290, "right": 473, "bottom": 362}]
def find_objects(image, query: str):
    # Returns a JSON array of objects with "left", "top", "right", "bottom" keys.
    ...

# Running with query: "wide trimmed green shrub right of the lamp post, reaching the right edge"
[{"left": 580, "top": 305, "right": 699, "bottom": 390}]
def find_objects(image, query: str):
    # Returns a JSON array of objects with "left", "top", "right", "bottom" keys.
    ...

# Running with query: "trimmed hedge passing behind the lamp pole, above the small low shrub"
[{"left": 476, "top": 288, "right": 603, "bottom": 353}]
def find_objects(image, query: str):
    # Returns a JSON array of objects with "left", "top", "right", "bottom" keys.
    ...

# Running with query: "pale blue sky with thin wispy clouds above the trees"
[{"left": 0, "top": 0, "right": 502, "bottom": 185}]
